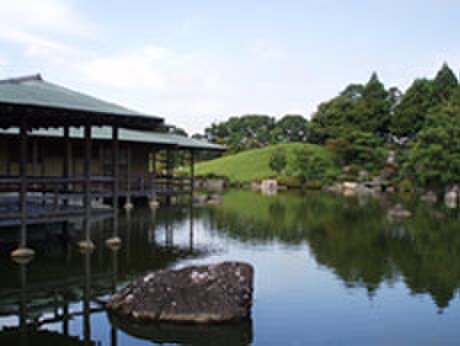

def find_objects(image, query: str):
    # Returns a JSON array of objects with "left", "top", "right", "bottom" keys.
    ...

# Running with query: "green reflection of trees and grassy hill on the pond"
[{"left": 208, "top": 191, "right": 460, "bottom": 309}]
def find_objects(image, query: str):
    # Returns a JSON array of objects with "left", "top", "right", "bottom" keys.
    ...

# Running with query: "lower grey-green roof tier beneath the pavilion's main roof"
[{"left": 0, "top": 127, "right": 226, "bottom": 151}]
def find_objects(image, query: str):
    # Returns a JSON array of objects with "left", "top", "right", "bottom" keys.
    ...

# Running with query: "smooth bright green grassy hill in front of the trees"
[{"left": 195, "top": 143, "right": 334, "bottom": 183}]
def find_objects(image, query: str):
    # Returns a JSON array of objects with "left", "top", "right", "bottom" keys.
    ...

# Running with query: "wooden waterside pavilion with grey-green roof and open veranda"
[{"left": 0, "top": 76, "right": 223, "bottom": 254}]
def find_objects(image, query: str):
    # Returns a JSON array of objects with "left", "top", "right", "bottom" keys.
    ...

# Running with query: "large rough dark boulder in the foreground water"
[{"left": 107, "top": 262, "right": 254, "bottom": 323}]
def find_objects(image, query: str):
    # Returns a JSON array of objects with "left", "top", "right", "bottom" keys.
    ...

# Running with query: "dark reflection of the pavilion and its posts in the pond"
[{"left": 0, "top": 210, "right": 202, "bottom": 345}]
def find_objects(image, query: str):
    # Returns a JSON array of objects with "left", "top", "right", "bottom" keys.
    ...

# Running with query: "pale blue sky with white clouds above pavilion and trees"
[{"left": 0, "top": 0, "right": 460, "bottom": 133}]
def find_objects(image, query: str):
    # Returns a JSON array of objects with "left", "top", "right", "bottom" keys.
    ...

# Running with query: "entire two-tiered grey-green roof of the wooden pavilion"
[{"left": 0, "top": 75, "right": 226, "bottom": 150}]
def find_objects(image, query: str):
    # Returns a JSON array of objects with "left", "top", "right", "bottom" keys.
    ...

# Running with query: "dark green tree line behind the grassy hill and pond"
[{"left": 194, "top": 64, "right": 460, "bottom": 191}]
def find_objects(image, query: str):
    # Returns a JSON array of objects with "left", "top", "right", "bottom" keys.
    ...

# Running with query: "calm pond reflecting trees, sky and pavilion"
[{"left": 0, "top": 190, "right": 460, "bottom": 345}]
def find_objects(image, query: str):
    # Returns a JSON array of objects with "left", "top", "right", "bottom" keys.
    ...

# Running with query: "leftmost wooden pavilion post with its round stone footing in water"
[{"left": 11, "top": 120, "right": 35, "bottom": 259}]
